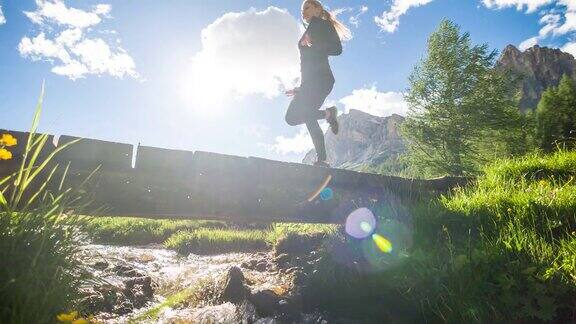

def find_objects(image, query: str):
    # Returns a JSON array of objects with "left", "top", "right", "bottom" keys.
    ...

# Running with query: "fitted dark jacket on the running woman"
[{"left": 298, "top": 17, "right": 342, "bottom": 82}]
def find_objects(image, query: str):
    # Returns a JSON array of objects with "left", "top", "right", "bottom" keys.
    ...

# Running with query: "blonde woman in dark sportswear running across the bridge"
[{"left": 286, "top": 0, "right": 350, "bottom": 167}]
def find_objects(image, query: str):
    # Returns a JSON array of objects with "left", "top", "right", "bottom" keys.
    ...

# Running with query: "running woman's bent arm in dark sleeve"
[{"left": 307, "top": 18, "right": 342, "bottom": 55}]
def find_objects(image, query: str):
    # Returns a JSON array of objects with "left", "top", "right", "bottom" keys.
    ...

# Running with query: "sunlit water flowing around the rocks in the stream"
[{"left": 82, "top": 244, "right": 290, "bottom": 323}]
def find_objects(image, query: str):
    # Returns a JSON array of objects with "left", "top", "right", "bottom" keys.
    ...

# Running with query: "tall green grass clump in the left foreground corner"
[{"left": 0, "top": 86, "right": 90, "bottom": 323}]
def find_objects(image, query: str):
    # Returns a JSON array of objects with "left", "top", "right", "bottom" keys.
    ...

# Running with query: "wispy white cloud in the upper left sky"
[{"left": 18, "top": 0, "right": 139, "bottom": 80}]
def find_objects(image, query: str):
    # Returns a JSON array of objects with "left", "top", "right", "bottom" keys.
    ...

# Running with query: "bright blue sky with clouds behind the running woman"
[{"left": 0, "top": 0, "right": 576, "bottom": 161}]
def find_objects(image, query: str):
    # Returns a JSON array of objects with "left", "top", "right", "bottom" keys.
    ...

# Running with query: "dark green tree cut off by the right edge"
[{"left": 536, "top": 75, "right": 576, "bottom": 152}]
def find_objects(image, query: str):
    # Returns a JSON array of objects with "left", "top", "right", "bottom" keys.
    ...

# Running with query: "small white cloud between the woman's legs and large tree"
[{"left": 339, "top": 86, "right": 408, "bottom": 117}]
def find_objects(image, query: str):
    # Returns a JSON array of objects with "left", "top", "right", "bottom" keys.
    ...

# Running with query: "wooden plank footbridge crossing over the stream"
[{"left": 0, "top": 130, "right": 469, "bottom": 223}]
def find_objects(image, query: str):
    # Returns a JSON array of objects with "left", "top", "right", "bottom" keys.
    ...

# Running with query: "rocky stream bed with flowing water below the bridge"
[{"left": 81, "top": 244, "right": 326, "bottom": 323}]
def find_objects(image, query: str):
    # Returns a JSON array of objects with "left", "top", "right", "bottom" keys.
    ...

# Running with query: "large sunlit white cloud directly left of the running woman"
[{"left": 182, "top": 7, "right": 302, "bottom": 105}]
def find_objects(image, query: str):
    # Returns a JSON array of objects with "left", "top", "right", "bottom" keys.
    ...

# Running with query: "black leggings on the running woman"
[{"left": 286, "top": 75, "right": 334, "bottom": 161}]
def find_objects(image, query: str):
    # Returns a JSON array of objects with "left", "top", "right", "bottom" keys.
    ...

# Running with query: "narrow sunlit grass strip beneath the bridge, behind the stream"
[{"left": 87, "top": 217, "right": 336, "bottom": 254}]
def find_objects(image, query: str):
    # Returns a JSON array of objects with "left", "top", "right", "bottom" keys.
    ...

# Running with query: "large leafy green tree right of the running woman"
[{"left": 402, "top": 20, "right": 524, "bottom": 176}]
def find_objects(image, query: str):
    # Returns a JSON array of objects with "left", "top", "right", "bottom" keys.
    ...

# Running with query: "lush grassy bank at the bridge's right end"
[{"left": 304, "top": 152, "right": 576, "bottom": 323}]
